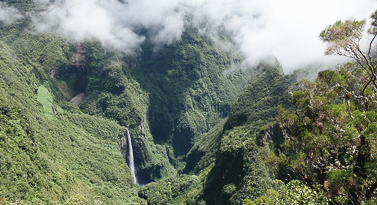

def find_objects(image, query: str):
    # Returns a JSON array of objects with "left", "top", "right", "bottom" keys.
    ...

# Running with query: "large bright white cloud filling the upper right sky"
[{"left": 186, "top": 0, "right": 377, "bottom": 72}]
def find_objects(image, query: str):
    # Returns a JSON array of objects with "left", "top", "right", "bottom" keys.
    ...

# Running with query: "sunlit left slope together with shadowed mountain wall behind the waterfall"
[{"left": 0, "top": 1, "right": 250, "bottom": 204}]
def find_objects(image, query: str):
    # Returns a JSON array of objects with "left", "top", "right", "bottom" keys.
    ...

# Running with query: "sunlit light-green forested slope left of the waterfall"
[{"left": 0, "top": 19, "right": 145, "bottom": 204}]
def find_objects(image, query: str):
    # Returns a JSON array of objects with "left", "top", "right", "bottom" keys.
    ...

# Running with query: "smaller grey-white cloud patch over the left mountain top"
[{"left": 34, "top": 0, "right": 144, "bottom": 53}]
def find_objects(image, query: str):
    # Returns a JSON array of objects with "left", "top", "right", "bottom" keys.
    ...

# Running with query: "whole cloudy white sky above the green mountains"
[{"left": 0, "top": 0, "right": 377, "bottom": 72}]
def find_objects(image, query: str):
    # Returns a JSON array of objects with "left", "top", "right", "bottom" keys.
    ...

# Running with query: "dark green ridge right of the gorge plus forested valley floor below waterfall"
[{"left": 139, "top": 58, "right": 296, "bottom": 204}]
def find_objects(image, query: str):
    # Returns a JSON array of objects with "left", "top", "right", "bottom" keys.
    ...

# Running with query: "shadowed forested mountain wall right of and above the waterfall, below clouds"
[{"left": 80, "top": 24, "right": 249, "bottom": 182}]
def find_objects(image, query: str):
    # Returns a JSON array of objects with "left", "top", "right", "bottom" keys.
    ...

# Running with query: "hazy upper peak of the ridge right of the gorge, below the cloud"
[{"left": 226, "top": 59, "right": 294, "bottom": 131}]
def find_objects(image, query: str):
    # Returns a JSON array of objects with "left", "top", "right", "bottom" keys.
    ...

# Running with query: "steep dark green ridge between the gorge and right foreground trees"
[{"left": 188, "top": 58, "right": 294, "bottom": 204}]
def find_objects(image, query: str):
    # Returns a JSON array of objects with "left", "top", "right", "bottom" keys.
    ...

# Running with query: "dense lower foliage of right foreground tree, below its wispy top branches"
[{"left": 278, "top": 66, "right": 377, "bottom": 204}]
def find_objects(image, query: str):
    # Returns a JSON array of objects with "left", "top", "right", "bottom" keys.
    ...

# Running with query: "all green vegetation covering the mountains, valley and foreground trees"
[{"left": 0, "top": 0, "right": 377, "bottom": 204}]
